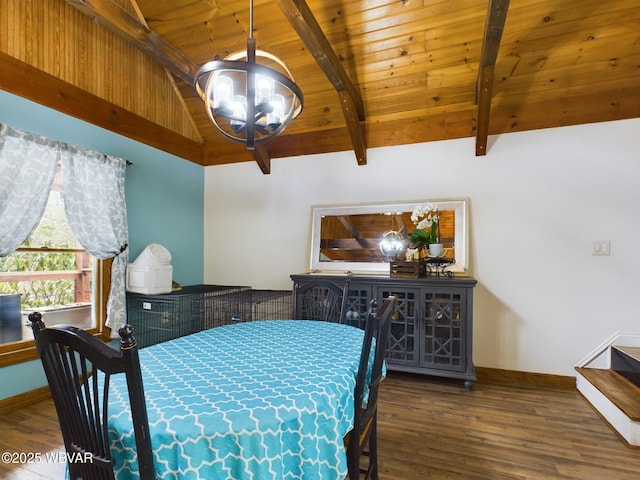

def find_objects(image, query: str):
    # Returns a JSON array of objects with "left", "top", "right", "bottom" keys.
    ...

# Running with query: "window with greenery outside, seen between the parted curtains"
[{"left": 0, "top": 164, "right": 111, "bottom": 365}]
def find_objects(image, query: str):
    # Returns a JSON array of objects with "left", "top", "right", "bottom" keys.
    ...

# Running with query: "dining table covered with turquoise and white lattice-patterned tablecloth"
[{"left": 108, "top": 320, "right": 372, "bottom": 480}]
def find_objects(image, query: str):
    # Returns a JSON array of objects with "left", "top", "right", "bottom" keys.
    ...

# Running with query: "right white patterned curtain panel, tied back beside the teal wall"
[{"left": 62, "top": 145, "right": 129, "bottom": 333}]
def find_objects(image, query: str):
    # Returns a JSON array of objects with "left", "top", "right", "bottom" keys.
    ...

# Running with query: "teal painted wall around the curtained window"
[{"left": 0, "top": 90, "right": 204, "bottom": 399}]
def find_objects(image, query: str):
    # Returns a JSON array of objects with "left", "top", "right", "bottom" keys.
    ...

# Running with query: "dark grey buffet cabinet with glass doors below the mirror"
[{"left": 291, "top": 273, "right": 477, "bottom": 390}]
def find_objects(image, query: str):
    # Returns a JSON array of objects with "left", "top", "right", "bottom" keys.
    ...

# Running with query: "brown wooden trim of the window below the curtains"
[{"left": 0, "top": 258, "right": 113, "bottom": 367}]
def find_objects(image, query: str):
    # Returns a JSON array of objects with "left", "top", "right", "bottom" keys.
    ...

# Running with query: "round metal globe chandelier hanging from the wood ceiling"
[{"left": 194, "top": 0, "right": 304, "bottom": 150}]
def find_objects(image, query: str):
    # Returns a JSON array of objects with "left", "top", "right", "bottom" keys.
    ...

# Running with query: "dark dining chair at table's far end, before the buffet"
[{"left": 293, "top": 279, "right": 349, "bottom": 323}]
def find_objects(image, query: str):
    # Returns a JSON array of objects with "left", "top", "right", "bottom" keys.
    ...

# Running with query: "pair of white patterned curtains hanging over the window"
[{"left": 0, "top": 124, "right": 129, "bottom": 335}]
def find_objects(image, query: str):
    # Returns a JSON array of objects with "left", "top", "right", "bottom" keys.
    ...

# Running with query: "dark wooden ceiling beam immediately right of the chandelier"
[{"left": 275, "top": 0, "right": 367, "bottom": 165}]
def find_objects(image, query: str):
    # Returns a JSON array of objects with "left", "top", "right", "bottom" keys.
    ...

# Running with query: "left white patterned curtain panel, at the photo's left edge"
[{"left": 0, "top": 124, "right": 60, "bottom": 257}]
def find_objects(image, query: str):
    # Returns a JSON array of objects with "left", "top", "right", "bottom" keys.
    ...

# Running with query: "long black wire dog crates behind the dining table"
[{"left": 127, "top": 285, "right": 292, "bottom": 348}]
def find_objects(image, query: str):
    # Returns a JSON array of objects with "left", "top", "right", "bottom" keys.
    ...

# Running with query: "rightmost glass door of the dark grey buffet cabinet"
[{"left": 420, "top": 291, "right": 466, "bottom": 371}]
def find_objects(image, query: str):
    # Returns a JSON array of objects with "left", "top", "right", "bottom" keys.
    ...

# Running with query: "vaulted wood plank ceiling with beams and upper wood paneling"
[{"left": 0, "top": 0, "right": 640, "bottom": 173}]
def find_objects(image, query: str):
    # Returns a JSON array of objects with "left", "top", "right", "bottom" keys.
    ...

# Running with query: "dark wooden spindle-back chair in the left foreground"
[{"left": 29, "top": 312, "right": 155, "bottom": 480}]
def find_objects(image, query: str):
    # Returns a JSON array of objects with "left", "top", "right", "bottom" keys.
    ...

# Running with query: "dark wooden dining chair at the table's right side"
[{"left": 345, "top": 296, "right": 396, "bottom": 480}]
